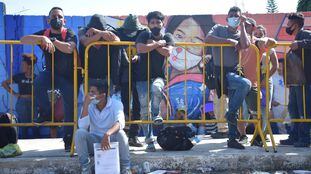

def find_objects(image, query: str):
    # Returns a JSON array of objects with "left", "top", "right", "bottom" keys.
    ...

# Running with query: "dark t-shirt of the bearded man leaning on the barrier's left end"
[{"left": 34, "top": 29, "right": 77, "bottom": 80}]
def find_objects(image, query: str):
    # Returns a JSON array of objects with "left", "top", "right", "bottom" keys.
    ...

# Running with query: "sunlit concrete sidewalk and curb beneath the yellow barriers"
[{"left": 0, "top": 135, "right": 311, "bottom": 174}]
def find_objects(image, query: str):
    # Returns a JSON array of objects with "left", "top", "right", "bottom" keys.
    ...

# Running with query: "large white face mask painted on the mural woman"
[{"left": 168, "top": 47, "right": 202, "bottom": 71}]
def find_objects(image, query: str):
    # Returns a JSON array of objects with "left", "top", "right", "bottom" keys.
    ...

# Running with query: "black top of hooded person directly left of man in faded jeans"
[{"left": 115, "top": 28, "right": 146, "bottom": 83}]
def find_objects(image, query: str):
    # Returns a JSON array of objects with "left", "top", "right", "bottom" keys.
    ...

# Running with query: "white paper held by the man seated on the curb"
[{"left": 94, "top": 142, "right": 120, "bottom": 174}]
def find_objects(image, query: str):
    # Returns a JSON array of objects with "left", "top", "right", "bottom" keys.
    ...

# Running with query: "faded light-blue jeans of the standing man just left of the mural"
[{"left": 136, "top": 78, "right": 164, "bottom": 144}]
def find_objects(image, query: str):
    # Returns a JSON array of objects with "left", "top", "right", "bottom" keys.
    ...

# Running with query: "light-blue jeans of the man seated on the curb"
[{"left": 75, "top": 129, "right": 130, "bottom": 170}]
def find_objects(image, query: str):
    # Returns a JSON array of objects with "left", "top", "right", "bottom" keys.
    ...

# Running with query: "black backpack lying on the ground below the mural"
[{"left": 157, "top": 126, "right": 195, "bottom": 151}]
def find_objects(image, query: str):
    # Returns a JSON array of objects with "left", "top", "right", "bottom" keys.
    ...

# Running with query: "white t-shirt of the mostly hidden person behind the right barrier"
[{"left": 272, "top": 72, "right": 289, "bottom": 105}]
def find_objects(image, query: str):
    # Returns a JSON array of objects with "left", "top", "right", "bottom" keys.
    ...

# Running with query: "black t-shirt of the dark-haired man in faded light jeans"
[{"left": 133, "top": 31, "right": 175, "bottom": 81}]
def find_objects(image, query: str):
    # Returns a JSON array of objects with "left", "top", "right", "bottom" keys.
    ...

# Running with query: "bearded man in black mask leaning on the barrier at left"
[{"left": 21, "top": 7, "right": 77, "bottom": 151}]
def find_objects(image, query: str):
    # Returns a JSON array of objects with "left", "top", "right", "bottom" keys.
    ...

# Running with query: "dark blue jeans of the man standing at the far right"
[{"left": 288, "top": 86, "right": 311, "bottom": 143}]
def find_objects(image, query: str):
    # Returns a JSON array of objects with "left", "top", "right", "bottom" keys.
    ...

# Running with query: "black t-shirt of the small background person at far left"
[{"left": 13, "top": 73, "right": 36, "bottom": 95}]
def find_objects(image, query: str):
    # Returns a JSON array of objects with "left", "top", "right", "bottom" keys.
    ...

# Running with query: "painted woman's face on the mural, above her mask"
[{"left": 173, "top": 18, "right": 205, "bottom": 56}]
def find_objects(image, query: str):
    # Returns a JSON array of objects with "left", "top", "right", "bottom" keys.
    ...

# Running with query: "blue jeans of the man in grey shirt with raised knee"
[{"left": 226, "top": 72, "right": 252, "bottom": 139}]
